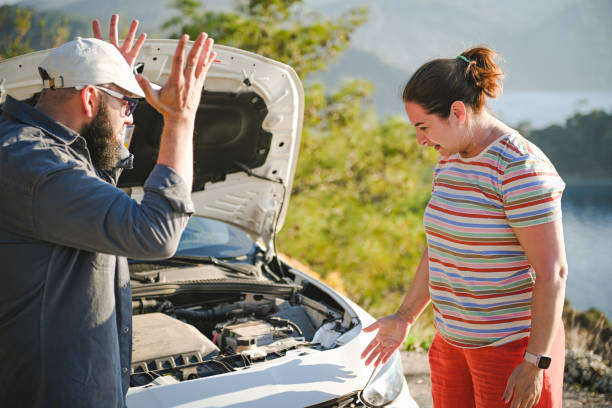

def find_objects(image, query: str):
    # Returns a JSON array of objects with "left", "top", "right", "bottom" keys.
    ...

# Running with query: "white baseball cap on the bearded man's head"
[{"left": 39, "top": 37, "right": 145, "bottom": 98}]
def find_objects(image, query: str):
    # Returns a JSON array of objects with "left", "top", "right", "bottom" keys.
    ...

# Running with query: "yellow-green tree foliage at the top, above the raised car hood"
[{"left": 162, "top": 0, "right": 366, "bottom": 78}]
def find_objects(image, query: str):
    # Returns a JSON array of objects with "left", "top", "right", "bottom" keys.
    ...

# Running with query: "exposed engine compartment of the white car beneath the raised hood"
[{"left": 130, "top": 292, "right": 351, "bottom": 387}]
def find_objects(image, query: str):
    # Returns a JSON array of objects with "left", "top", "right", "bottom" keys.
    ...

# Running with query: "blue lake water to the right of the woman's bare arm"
[{"left": 562, "top": 180, "right": 612, "bottom": 318}]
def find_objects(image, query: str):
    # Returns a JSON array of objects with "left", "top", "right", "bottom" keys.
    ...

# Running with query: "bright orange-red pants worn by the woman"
[{"left": 429, "top": 325, "right": 565, "bottom": 408}]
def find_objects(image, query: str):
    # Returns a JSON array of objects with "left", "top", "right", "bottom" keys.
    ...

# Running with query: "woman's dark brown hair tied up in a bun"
[{"left": 402, "top": 46, "right": 504, "bottom": 118}]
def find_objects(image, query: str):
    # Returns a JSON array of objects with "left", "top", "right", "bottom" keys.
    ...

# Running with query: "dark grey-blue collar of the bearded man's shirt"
[{"left": 2, "top": 95, "right": 80, "bottom": 145}]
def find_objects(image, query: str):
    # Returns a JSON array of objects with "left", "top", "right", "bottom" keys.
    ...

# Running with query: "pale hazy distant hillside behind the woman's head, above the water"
[{"left": 344, "top": 0, "right": 612, "bottom": 89}]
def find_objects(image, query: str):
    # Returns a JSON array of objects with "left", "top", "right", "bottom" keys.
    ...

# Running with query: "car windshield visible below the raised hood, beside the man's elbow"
[{"left": 176, "top": 216, "right": 255, "bottom": 259}]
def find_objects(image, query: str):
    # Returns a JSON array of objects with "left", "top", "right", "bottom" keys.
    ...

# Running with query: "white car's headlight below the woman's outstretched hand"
[{"left": 361, "top": 351, "right": 404, "bottom": 407}]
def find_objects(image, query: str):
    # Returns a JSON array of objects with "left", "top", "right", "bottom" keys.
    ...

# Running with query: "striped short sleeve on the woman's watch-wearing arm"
[{"left": 502, "top": 155, "right": 565, "bottom": 227}]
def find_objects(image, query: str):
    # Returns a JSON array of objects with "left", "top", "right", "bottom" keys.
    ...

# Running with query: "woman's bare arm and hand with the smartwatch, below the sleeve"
[{"left": 503, "top": 219, "right": 567, "bottom": 408}]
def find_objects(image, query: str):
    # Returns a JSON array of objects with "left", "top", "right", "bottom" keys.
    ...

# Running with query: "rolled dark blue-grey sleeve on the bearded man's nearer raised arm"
[{"left": 32, "top": 165, "right": 193, "bottom": 259}]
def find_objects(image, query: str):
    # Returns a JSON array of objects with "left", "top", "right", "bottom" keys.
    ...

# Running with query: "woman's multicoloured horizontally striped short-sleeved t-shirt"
[{"left": 424, "top": 133, "right": 565, "bottom": 348}]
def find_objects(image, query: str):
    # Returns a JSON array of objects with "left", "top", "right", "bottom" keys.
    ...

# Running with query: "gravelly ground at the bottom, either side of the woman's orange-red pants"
[{"left": 401, "top": 351, "right": 612, "bottom": 408}]
